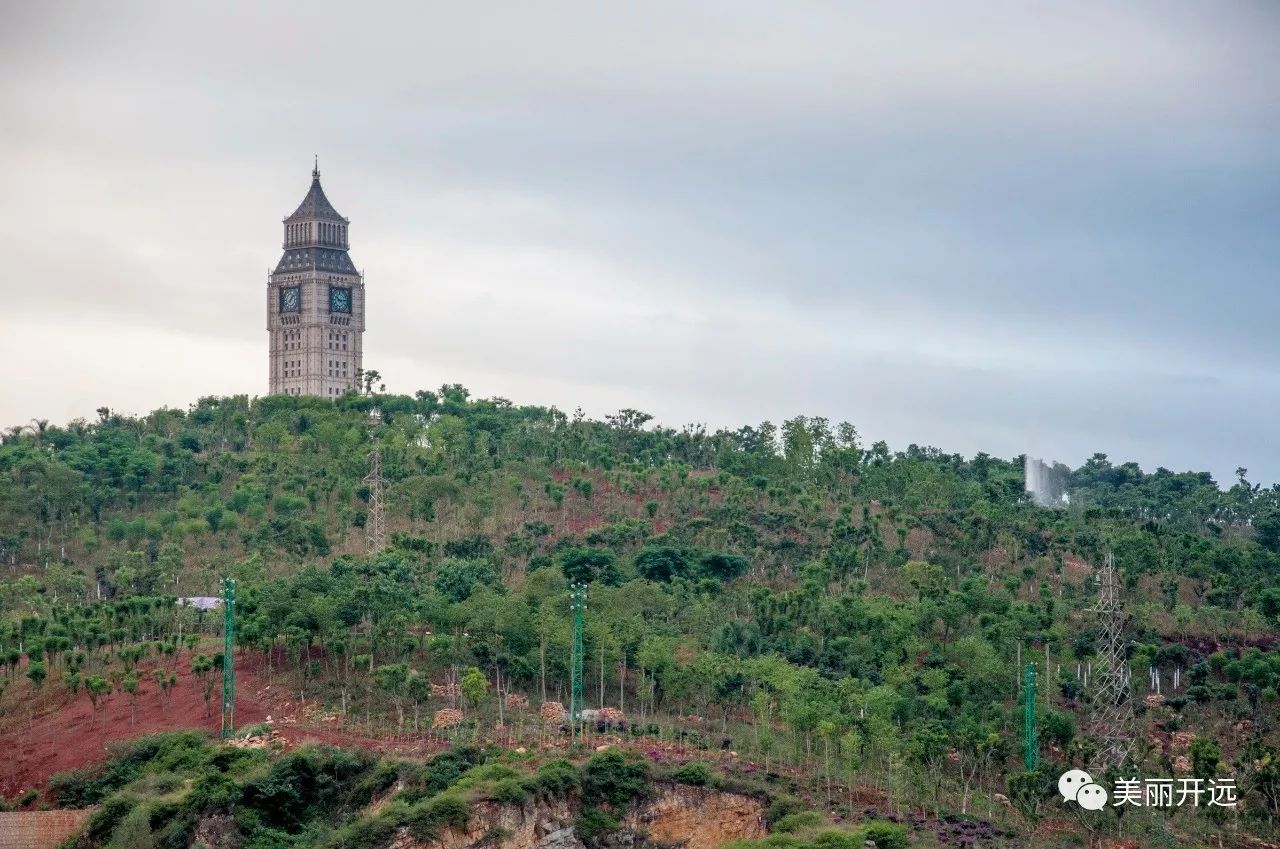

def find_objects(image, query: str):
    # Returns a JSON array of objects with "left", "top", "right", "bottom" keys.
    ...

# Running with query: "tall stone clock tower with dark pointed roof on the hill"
[{"left": 266, "top": 164, "right": 365, "bottom": 398}]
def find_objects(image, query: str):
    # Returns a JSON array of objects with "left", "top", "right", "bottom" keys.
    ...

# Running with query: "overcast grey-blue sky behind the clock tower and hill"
[{"left": 0, "top": 0, "right": 1280, "bottom": 483}]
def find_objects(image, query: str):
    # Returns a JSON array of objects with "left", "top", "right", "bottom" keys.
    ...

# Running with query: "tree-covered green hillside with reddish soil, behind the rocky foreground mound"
[{"left": 0, "top": 385, "right": 1280, "bottom": 845}]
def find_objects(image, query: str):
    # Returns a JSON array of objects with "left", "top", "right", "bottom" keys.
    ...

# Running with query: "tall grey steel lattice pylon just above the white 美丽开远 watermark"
[{"left": 1092, "top": 552, "right": 1134, "bottom": 768}]
